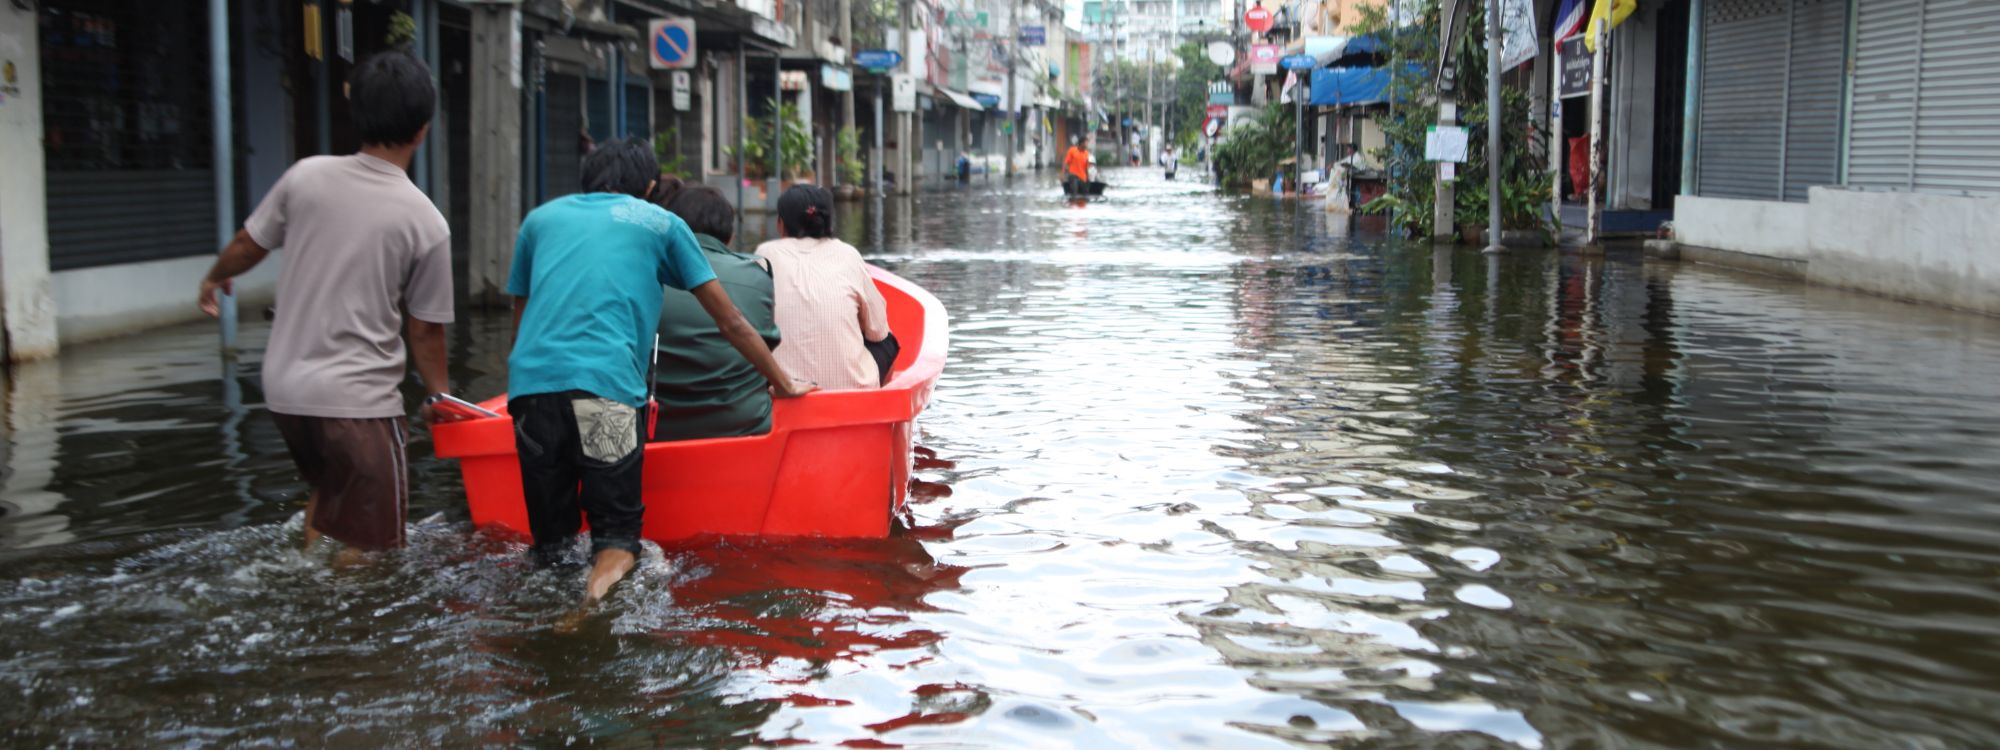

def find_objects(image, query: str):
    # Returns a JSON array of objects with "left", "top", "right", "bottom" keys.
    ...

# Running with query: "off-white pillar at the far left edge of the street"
[{"left": 0, "top": 2, "right": 60, "bottom": 362}]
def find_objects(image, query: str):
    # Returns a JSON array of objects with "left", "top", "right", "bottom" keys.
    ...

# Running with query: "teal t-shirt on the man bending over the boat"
[{"left": 506, "top": 192, "right": 716, "bottom": 406}]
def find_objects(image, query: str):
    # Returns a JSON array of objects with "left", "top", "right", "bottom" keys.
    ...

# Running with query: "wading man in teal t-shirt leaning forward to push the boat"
[{"left": 506, "top": 140, "right": 812, "bottom": 604}]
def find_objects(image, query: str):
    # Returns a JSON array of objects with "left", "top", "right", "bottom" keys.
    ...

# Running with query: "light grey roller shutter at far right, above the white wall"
[{"left": 1846, "top": 0, "right": 2000, "bottom": 196}]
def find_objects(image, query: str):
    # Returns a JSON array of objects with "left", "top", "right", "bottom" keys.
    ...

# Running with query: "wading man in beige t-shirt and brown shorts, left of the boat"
[{"left": 200, "top": 52, "right": 452, "bottom": 550}]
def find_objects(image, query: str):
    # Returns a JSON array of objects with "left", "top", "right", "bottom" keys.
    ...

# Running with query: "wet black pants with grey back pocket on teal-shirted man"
[{"left": 506, "top": 390, "right": 646, "bottom": 564}]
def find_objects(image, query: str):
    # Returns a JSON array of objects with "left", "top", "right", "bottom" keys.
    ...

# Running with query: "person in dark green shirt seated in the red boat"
[{"left": 652, "top": 184, "right": 780, "bottom": 440}]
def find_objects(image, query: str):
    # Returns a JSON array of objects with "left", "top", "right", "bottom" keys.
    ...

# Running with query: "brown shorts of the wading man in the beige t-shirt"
[{"left": 272, "top": 414, "right": 410, "bottom": 550}]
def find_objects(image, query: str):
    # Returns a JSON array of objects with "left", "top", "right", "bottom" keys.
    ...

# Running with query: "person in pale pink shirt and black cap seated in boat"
[{"left": 756, "top": 184, "right": 892, "bottom": 390}]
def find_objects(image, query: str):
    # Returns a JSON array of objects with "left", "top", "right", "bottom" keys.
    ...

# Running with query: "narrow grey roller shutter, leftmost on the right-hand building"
[{"left": 1694, "top": 0, "right": 1786, "bottom": 200}]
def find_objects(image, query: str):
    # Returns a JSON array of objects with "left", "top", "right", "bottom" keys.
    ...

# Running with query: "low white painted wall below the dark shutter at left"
[{"left": 44, "top": 252, "right": 284, "bottom": 346}]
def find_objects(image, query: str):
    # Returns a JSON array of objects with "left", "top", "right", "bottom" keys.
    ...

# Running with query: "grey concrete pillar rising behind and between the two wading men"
[{"left": 466, "top": 4, "right": 522, "bottom": 306}]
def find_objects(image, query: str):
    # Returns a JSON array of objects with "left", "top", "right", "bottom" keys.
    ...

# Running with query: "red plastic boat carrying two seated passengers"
[{"left": 432, "top": 266, "right": 948, "bottom": 540}]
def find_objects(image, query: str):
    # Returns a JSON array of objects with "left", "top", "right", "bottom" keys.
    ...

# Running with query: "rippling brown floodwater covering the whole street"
[{"left": 0, "top": 170, "right": 2000, "bottom": 748}]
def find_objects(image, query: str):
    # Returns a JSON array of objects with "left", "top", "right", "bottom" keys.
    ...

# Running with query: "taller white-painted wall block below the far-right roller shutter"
[{"left": 1800, "top": 188, "right": 2000, "bottom": 314}]
